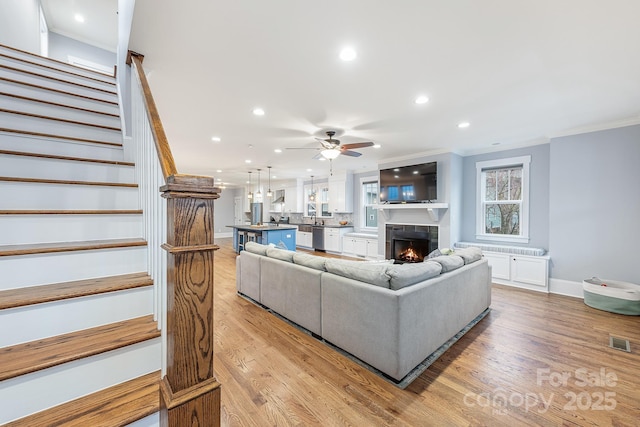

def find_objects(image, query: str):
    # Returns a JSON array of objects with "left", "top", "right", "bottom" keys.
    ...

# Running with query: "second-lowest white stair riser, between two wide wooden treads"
[{"left": 0, "top": 286, "right": 153, "bottom": 347}]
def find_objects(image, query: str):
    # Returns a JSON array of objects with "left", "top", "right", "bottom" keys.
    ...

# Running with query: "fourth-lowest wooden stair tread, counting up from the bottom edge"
[{"left": 0, "top": 238, "right": 147, "bottom": 256}]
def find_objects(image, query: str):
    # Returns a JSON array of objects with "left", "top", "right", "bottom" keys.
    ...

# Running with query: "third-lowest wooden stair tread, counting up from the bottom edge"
[{"left": 0, "top": 272, "right": 153, "bottom": 310}]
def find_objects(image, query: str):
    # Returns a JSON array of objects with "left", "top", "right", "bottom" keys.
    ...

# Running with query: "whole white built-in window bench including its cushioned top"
[{"left": 454, "top": 242, "right": 550, "bottom": 292}]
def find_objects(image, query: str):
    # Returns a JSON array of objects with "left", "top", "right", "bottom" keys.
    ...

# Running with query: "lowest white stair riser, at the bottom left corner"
[{"left": 0, "top": 338, "right": 162, "bottom": 424}]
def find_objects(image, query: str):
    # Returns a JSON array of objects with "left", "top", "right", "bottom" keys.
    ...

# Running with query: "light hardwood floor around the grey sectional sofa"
[{"left": 214, "top": 239, "right": 640, "bottom": 427}]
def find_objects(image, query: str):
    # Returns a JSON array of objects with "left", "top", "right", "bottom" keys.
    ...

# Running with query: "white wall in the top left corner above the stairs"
[{"left": 0, "top": 0, "right": 40, "bottom": 55}]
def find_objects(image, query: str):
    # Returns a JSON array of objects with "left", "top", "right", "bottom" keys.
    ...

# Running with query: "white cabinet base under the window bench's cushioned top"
[{"left": 483, "top": 251, "right": 549, "bottom": 291}]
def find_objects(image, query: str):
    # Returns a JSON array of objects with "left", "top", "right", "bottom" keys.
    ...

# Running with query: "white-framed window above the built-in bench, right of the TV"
[{"left": 476, "top": 156, "right": 531, "bottom": 243}]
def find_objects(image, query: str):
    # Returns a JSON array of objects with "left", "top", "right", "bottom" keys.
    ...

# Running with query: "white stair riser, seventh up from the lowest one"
[{"left": 0, "top": 132, "right": 124, "bottom": 160}]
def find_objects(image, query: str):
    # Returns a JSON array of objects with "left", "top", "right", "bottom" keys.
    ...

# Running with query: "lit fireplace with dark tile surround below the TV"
[{"left": 385, "top": 224, "right": 438, "bottom": 263}]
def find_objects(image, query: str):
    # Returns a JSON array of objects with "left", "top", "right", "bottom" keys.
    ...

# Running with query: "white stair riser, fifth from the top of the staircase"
[{"left": 0, "top": 94, "right": 120, "bottom": 129}]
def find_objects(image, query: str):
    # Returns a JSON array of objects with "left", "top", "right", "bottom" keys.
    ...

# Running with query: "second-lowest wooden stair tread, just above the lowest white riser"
[{"left": 0, "top": 314, "right": 160, "bottom": 381}]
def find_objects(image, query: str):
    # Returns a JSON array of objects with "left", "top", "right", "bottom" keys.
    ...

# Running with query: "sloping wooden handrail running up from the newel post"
[{"left": 127, "top": 51, "right": 178, "bottom": 182}]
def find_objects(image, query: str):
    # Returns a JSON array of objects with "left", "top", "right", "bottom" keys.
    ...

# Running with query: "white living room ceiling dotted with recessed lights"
[{"left": 43, "top": 0, "right": 640, "bottom": 185}]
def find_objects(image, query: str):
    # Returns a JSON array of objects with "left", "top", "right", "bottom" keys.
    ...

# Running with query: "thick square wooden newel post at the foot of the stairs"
[{"left": 160, "top": 175, "right": 220, "bottom": 427}]
